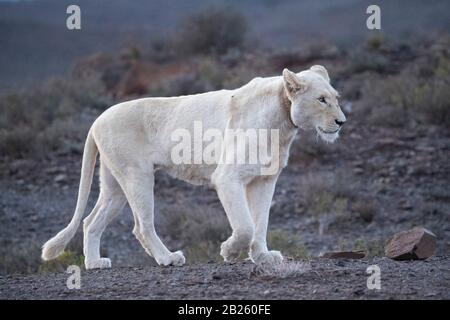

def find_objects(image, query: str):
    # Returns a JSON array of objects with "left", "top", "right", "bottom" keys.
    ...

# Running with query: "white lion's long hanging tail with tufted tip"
[{"left": 42, "top": 131, "right": 98, "bottom": 260}]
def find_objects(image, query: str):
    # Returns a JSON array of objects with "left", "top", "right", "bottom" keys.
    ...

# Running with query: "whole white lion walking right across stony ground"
[{"left": 42, "top": 65, "right": 345, "bottom": 269}]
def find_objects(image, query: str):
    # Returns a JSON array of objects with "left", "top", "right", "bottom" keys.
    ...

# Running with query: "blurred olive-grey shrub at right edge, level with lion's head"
[{"left": 362, "top": 43, "right": 450, "bottom": 127}]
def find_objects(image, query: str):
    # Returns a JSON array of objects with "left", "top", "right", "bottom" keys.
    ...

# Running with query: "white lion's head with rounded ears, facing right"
[{"left": 283, "top": 65, "right": 346, "bottom": 142}]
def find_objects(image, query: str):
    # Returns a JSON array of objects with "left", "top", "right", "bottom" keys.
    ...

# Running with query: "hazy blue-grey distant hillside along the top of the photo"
[{"left": 0, "top": 0, "right": 450, "bottom": 91}]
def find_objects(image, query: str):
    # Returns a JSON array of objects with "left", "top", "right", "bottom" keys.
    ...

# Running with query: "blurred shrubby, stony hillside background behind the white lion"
[{"left": 0, "top": 0, "right": 450, "bottom": 273}]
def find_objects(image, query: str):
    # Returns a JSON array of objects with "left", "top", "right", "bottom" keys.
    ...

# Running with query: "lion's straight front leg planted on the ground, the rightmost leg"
[{"left": 247, "top": 174, "right": 283, "bottom": 264}]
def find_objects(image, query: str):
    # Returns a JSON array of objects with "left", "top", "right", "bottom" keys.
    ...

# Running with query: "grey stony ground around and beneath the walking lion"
[{"left": 0, "top": 114, "right": 450, "bottom": 299}]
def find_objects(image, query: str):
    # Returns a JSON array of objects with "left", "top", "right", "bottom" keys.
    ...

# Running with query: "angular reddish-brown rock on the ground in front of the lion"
[{"left": 384, "top": 227, "right": 436, "bottom": 260}]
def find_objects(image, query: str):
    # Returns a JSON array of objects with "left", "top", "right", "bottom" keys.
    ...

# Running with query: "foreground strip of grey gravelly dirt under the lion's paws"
[{"left": 0, "top": 257, "right": 450, "bottom": 299}]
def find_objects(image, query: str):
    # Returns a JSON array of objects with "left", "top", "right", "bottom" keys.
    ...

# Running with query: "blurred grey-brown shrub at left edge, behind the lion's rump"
[{"left": 0, "top": 78, "right": 108, "bottom": 157}]
